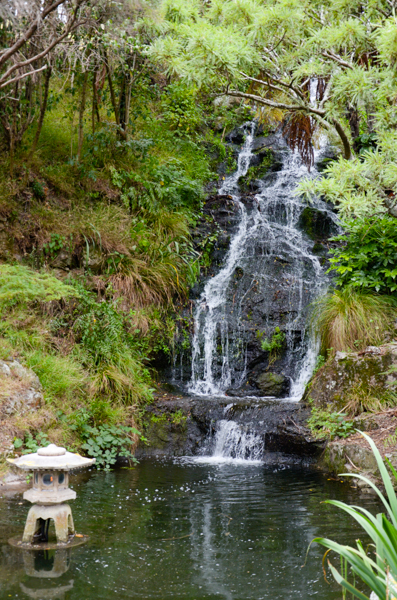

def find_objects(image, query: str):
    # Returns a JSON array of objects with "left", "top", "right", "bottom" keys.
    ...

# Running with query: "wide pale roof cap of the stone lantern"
[{"left": 7, "top": 444, "right": 95, "bottom": 471}]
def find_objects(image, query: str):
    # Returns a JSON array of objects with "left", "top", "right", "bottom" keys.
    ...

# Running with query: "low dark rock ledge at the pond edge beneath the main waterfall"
[{"left": 136, "top": 398, "right": 325, "bottom": 463}]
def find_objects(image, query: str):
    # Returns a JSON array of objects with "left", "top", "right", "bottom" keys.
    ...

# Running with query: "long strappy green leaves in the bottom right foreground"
[{"left": 312, "top": 433, "right": 397, "bottom": 600}]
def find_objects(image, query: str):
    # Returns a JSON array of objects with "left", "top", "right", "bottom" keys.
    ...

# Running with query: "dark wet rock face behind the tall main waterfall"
[{"left": 163, "top": 127, "right": 336, "bottom": 398}]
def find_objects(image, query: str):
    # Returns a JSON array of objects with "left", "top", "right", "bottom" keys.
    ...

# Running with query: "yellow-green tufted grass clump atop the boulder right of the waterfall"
[{"left": 312, "top": 286, "right": 397, "bottom": 352}]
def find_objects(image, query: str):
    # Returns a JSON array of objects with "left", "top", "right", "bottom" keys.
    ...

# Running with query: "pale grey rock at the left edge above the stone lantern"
[{"left": 0, "top": 360, "right": 43, "bottom": 453}]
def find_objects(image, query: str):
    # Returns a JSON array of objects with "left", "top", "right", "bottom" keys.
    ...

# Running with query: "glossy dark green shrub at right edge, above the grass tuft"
[{"left": 330, "top": 216, "right": 397, "bottom": 294}]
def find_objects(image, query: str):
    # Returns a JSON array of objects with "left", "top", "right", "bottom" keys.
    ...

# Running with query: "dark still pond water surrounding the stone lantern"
[{"left": 0, "top": 459, "right": 379, "bottom": 600}]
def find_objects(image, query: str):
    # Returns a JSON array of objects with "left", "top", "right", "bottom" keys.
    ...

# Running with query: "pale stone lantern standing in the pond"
[{"left": 7, "top": 444, "right": 95, "bottom": 544}]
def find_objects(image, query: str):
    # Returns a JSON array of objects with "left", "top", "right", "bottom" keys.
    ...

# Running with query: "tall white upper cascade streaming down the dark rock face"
[{"left": 189, "top": 123, "right": 336, "bottom": 400}]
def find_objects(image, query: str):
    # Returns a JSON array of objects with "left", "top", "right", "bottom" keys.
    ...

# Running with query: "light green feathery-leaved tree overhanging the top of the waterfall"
[{"left": 143, "top": 0, "right": 397, "bottom": 216}]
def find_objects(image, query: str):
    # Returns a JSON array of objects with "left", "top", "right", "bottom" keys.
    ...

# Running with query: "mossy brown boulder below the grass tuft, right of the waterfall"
[{"left": 304, "top": 342, "right": 397, "bottom": 410}]
